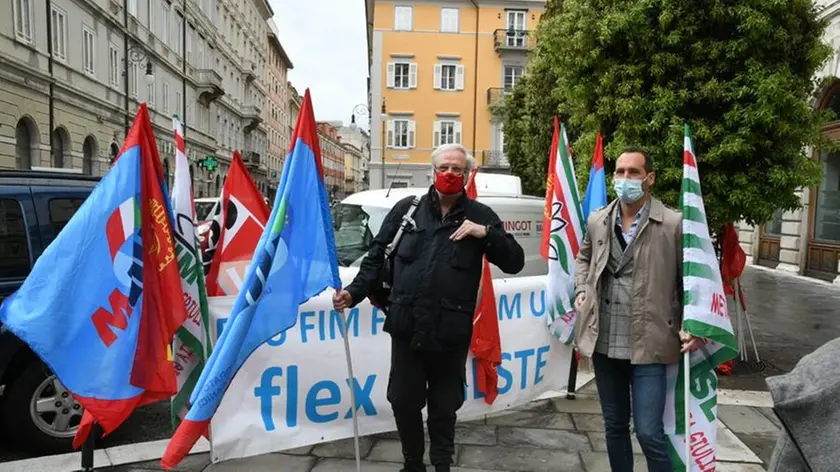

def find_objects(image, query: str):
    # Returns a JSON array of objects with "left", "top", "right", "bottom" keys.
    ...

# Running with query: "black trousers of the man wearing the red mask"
[{"left": 388, "top": 338, "right": 469, "bottom": 471}]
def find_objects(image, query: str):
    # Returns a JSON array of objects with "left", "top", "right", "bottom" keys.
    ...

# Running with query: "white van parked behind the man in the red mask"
[{"left": 333, "top": 179, "right": 548, "bottom": 278}]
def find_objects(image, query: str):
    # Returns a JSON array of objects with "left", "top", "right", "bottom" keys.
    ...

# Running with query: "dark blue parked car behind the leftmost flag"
[{"left": 0, "top": 171, "right": 99, "bottom": 454}]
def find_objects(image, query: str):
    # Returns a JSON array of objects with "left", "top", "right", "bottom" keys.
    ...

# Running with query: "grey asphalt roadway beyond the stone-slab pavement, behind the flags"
[{"left": 0, "top": 267, "right": 840, "bottom": 462}]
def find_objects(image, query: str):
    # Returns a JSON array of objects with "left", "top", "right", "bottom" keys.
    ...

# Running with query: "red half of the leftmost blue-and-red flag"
[{"left": 73, "top": 103, "right": 187, "bottom": 448}]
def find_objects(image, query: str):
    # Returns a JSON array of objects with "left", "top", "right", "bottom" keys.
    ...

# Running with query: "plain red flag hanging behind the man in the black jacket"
[{"left": 467, "top": 169, "right": 502, "bottom": 405}]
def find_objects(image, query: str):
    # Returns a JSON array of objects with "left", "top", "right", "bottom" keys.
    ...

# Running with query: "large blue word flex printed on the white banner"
[{"left": 254, "top": 366, "right": 377, "bottom": 431}]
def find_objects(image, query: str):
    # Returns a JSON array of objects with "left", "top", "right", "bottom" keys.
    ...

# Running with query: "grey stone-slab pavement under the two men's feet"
[{"left": 103, "top": 384, "right": 780, "bottom": 472}]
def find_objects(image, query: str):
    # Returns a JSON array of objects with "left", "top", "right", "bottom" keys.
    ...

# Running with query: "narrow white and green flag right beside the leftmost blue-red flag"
[{"left": 172, "top": 116, "right": 210, "bottom": 428}]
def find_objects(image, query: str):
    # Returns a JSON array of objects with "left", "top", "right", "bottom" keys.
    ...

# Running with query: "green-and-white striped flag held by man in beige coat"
[{"left": 664, "top": 125, "right": 738, "bottom": 472}]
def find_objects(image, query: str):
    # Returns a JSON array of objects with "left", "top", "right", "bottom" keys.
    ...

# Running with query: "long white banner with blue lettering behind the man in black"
[{"left": 210, "top": 271, "right": 572, "bottom": 462}]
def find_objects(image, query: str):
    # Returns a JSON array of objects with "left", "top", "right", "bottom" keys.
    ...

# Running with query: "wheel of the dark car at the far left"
[{"left": 2, "top": 361, "right": 83, "bottom": 455}]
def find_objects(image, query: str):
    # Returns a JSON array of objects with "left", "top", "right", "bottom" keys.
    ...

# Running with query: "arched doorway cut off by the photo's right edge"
[{"left": 805, "top": 81, "right": 840, "bottom": 280}]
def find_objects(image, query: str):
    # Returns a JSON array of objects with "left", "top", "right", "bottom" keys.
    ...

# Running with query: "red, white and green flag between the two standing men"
[{"left": 542, "top": 117, "right": 586, "bottom": 344}]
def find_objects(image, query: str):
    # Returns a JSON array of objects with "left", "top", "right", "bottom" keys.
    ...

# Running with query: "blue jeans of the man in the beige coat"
[{"left": 592, "top": 353, "right": 673, "bottom": 472}]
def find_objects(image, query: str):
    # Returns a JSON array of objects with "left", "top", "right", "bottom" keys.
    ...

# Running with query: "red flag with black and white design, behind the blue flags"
[{"left": 204, "top": 151, "right": 270, "bottom": 297}]
